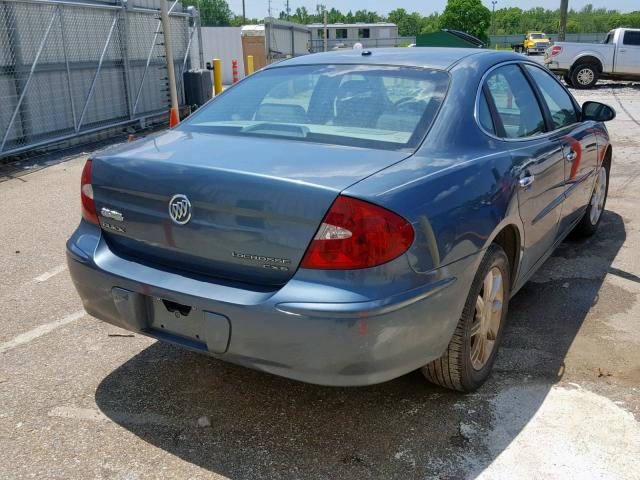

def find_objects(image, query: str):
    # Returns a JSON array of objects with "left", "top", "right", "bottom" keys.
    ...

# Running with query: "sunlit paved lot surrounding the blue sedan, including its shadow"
[{"left": 0, "top": 83, "right": 640, "bottom": 479}]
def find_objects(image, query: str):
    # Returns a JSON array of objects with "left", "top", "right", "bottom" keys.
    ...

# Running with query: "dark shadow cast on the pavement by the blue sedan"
[{"left": 95, "top": 211, "right": 624, "bottom": 479}]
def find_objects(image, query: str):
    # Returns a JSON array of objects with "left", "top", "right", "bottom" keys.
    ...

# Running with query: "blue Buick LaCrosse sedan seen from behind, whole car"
[{"left": 67, "top": 48, "right": 615, "bottom": 392}]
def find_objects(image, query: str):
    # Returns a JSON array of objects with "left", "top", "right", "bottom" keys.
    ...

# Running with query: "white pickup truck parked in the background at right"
[{"left": 544, "top": 28, "right": 640, "bottom": 88}]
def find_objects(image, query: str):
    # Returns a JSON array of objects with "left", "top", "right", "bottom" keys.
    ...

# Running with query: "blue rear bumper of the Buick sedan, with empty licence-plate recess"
[{"left": 67, "top": 222, "right": 481, "bottom": 386}]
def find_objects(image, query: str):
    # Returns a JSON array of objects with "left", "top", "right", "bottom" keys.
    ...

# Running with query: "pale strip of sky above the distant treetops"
[{"left": 227, "top": 0, "right": 640, "bottom": 18}]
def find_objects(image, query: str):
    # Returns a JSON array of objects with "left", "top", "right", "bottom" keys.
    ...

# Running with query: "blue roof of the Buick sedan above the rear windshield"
[{"left": 267, "top": 47, "right": 523, "bottom": 70}]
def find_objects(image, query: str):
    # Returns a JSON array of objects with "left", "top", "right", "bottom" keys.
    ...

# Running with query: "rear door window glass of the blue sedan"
[{"left": 487, "top": 64, "right": 545, "bottom": 138}]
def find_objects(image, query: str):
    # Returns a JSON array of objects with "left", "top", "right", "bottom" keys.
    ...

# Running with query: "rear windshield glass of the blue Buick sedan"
[{"left": 178, "top": 65, "right": 449, "bottom": 150}]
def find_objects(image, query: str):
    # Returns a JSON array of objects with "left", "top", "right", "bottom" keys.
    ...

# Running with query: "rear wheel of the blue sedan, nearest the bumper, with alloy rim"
[{"left": 421, "top": 243, "right": 511, "bottom": 392}]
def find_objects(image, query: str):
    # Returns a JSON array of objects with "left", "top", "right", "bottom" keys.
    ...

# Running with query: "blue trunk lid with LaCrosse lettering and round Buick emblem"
[{"left": 92, "top": 130, "right": 409, "bottom": 285}]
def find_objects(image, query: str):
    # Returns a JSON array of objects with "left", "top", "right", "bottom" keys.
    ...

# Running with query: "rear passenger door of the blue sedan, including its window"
[{"left": 484, "top": 63, "right": 564, "bottom": 274}]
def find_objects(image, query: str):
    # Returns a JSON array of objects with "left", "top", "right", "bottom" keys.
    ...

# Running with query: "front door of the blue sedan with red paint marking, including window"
[{"left": 525, "top": 65, "right": 598, "bottom": 234}]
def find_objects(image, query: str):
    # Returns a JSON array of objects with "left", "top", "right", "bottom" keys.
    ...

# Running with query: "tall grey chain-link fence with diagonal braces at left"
[{"left": 0, "top": 0, "right": 198, "bottom": 158}]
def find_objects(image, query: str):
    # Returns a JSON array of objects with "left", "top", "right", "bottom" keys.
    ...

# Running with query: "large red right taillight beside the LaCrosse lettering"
[{"left": 300, "top": 196, "right": 414, "bottom": 270}]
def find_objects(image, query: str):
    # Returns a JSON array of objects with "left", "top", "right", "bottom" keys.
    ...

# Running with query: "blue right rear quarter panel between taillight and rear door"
[{"left": 345, "top": 57, "right": 523, "bottom": 273}]
